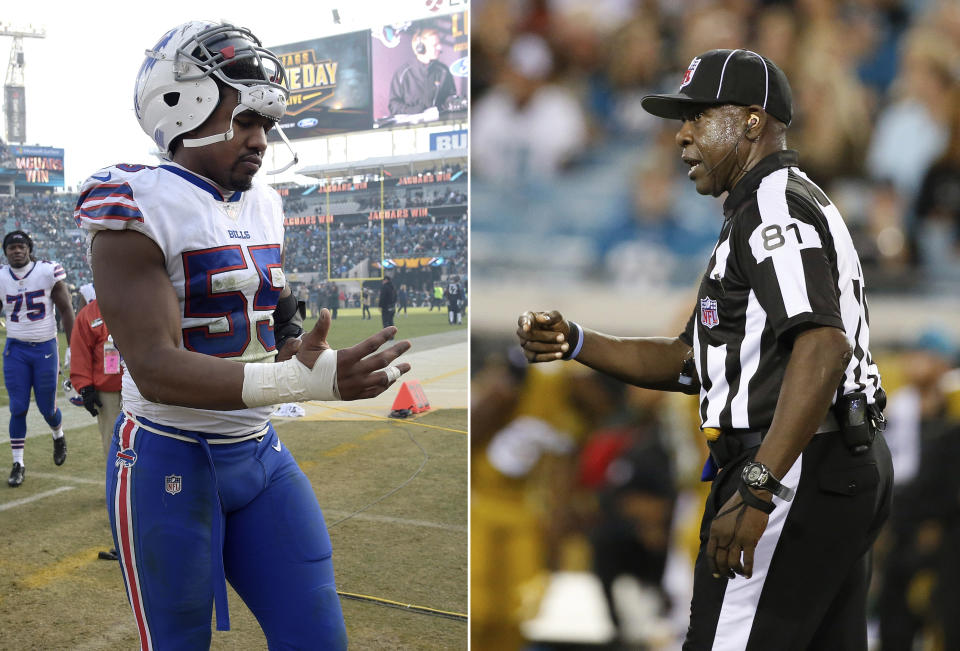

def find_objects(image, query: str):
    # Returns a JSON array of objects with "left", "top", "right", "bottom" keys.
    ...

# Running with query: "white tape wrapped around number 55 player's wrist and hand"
[{"left": 243, "top": 349, "right": 340, "bottom": 407}]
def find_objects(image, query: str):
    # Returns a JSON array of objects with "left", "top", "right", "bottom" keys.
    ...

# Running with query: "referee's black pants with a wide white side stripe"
[{"left": 683, "top": 433, "right": 893, "bottom": 651}]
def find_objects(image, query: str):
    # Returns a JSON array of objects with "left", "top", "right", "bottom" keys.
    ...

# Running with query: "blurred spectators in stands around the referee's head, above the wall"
[{"left": 471, "top": 0, "right": 960, "bottom": 291}]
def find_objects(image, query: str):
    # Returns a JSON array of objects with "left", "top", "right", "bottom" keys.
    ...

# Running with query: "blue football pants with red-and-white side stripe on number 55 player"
[{"left": 107, "top": 413, "right": 347, "bottom": 651}]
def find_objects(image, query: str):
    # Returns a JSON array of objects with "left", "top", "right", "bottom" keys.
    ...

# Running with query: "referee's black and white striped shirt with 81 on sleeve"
[{"left": 680, "top": 150, "right": 880, "bottom": 429}]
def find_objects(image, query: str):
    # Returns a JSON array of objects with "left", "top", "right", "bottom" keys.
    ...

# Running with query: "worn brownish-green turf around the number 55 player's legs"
[{"left": 0, "top": 410, "right": 467, "bottom": 649}]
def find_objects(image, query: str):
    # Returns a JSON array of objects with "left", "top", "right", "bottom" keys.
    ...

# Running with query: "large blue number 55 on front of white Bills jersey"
[{"left": 182, "top": 244, "right": 282, "bottom": 357}]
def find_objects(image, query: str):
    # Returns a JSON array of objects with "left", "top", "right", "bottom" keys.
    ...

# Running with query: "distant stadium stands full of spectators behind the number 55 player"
[{"left": 0, "top": 176, "right": 467, "bottom": 316}]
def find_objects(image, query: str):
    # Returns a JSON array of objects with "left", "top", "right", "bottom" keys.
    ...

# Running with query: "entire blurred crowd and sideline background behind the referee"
[{"left": 470, "top": 0, "right": 960, "bottom": 651}]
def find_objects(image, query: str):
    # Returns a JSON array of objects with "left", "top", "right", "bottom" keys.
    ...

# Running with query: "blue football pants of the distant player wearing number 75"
[{"left": 3, "top": 338, "right": 63, "bottom": 440}]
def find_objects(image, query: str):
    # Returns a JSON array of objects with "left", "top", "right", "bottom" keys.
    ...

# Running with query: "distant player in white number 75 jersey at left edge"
[{"left": 0, "top": 230, "right": 73, "bottom": 488}]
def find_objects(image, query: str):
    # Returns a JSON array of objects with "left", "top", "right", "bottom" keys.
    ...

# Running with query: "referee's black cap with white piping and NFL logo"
[{"left": 641, "top": 50, "right": 793, "bottom": 125}]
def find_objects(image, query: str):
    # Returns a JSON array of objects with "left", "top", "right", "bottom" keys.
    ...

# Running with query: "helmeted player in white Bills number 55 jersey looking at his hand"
[{"left": 75, "top": 21, "right": 410, "bottom": 650}]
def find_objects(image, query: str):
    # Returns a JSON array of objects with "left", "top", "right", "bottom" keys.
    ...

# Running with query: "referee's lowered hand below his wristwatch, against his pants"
[{"left": 707, "top": 493, "right": 768, "bottom": 579}]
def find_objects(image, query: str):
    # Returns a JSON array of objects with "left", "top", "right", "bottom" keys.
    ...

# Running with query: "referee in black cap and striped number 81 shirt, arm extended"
[{"left": 517, "top": 50, "right": 893, "bottom": 651}]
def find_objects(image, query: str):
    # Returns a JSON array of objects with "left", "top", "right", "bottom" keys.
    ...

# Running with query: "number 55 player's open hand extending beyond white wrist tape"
[{"left": 297, "top": 308, "right": 410, "bottom": 400}]
